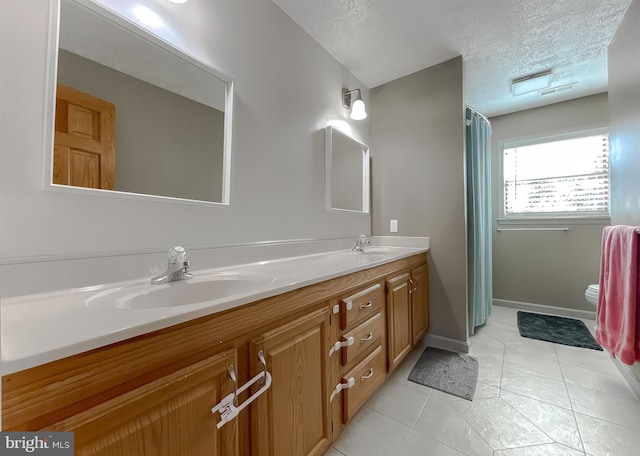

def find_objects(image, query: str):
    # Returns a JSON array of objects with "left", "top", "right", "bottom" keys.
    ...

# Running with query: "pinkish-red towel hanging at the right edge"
[{"left": 596, "top": 225, "right": 640, "bottom": 364}]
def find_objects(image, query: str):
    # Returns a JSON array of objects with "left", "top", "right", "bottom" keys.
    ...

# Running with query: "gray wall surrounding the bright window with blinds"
[{"left": 491, "top": 94, "right": 609, "bottom": 312}]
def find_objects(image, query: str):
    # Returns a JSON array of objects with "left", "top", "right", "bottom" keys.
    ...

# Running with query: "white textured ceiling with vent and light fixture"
[{"left": 273, "top": 0, "right": 631, "bottom": 116}]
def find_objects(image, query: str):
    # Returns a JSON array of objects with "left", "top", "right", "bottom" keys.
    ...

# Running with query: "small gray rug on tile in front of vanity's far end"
[{"left": 409, "top": 347, "right": 478, "bottom": 401}]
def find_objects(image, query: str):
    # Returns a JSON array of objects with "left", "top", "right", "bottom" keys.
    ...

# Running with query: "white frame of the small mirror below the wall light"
[{"left": 324, "top": 125, "right": 371, "bottom": 214}]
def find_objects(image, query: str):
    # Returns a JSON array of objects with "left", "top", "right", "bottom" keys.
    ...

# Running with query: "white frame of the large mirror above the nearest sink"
[{"left": 42, "top": 0, "right": 234, "bottom": 206}]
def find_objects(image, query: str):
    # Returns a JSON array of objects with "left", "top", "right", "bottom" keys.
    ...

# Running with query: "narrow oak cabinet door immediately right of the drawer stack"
[{"left": 387, "top": 272, "right": 412, "bottom": 373}]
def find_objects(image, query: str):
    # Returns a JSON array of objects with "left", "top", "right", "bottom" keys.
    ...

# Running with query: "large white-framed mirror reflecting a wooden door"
[{"left": 47, "top": 0, "right": 233, "bottom": 204}]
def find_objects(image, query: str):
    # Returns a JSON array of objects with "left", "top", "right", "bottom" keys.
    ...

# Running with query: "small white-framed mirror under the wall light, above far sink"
[{"left": 324, "top": 126, "right": 369, "bottom": 213}]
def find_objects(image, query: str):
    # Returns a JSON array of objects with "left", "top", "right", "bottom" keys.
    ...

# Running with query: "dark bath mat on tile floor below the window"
[{"left": 518, "top": 311, "right": 602, "bottom": 351}]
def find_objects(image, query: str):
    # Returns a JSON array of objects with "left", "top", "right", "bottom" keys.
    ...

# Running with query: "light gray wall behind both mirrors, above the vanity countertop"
[{"left": 0, "top": 0, "right": 371, "bottom": 264}]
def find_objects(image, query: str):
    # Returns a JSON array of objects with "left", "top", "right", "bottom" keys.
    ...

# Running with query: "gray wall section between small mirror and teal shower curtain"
[{"left": 370, "top": 57, "right": 467, "bottom": 341}]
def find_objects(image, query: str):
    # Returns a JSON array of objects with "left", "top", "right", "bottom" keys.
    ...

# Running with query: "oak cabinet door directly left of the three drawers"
[{"left": 250, "top": 305, "right": 332, "bottom": 456}]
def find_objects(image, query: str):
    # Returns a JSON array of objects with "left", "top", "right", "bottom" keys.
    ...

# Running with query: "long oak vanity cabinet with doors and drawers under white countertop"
[{"left": 2, "top": 255, "right": 428, "bottom": 456}]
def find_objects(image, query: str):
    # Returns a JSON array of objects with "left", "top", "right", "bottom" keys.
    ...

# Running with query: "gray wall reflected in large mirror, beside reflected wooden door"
[{"left": 58, "top": 49, "right": 224, "bottom": 202}]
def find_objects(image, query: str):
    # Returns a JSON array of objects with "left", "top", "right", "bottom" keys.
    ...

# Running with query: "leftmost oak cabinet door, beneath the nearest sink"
[{"left": 47, "top": 351, "right": 238, "bottom": 456}]
